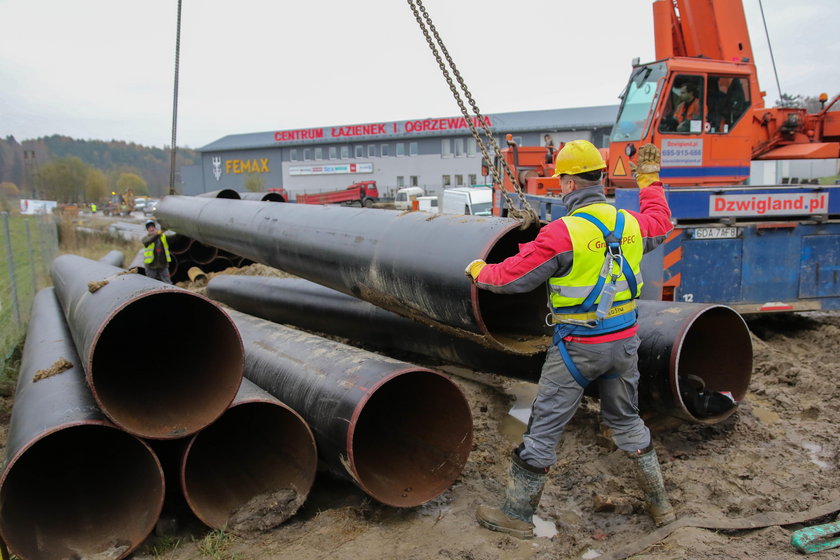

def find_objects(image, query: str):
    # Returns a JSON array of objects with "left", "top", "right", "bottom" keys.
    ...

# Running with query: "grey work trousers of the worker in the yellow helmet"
[{"left": 519, "top": 335, "right": 650, "bottom": 468}]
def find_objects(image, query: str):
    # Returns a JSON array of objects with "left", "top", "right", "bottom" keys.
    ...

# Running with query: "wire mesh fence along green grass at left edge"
[{"left": 0, "top": 212, "right": 58, "bottom": 376}]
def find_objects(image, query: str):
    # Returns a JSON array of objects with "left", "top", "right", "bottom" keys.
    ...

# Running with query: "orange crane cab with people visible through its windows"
[{"left": 608, "top": 58, "right": 760, "bottom": 187}]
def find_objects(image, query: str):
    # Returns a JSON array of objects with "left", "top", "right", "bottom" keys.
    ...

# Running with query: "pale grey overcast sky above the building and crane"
[{"left": 0, "top": 0, "right": 840, "bottom": 148}]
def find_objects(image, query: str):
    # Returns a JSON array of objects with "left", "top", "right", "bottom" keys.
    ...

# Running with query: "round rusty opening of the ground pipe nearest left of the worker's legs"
[{"left": 348, "top": 371, "right": 472, "bottom": 507}]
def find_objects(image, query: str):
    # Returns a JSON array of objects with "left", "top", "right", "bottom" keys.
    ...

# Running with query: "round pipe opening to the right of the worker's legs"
[{"left": 671, "top": 307, "right": 752, "bottom": 422}]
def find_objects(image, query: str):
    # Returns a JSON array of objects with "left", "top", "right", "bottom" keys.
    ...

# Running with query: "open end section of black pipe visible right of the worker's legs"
[{"left": 639, "top": 300, "right": 752, "bottom": 424}]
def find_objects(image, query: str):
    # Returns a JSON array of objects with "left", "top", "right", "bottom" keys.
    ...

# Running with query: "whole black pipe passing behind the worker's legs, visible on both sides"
[{"left": 207, "top": 275, "right": 752, "bottom": 424}]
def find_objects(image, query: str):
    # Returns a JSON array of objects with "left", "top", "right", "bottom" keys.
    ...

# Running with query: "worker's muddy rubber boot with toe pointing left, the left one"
[{"left": 475, "top": 451, "right": 548, "bottom": 539}]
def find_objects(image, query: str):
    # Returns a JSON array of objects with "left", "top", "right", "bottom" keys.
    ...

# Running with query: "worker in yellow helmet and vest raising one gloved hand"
[{"left": 465, "top": 140, "right": 676, "bottom": 538}]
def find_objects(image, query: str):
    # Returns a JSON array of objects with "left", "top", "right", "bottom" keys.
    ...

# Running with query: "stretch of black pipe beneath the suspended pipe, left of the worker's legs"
[{"left": 207, "top": 275, "right": 545, "bottom": 381}]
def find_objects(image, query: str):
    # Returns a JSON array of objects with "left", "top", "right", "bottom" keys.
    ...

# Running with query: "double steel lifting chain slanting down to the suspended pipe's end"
[{"left": 408, "top": 0, "right": 539, "bottom": 229}]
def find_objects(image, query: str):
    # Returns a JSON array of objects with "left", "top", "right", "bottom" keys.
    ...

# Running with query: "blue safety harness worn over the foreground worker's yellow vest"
[{"left": 546, "top": 212, "right": 638, "bottom": 389}]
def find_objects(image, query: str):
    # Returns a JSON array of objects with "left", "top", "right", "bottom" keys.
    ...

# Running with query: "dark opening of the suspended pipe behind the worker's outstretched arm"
[{"left": 477, "top": 224, "right": 550, "bottom": 351}]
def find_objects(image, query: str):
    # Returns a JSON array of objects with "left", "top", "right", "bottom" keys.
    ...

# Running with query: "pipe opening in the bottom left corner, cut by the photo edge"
[{"left": 0, "top": 425, "right": 164, "bottom": 560}]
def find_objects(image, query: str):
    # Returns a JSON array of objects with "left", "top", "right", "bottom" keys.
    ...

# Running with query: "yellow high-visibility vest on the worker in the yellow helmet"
[{"left": 548, "top": 203, "right": 644, "bottom": 314}]
